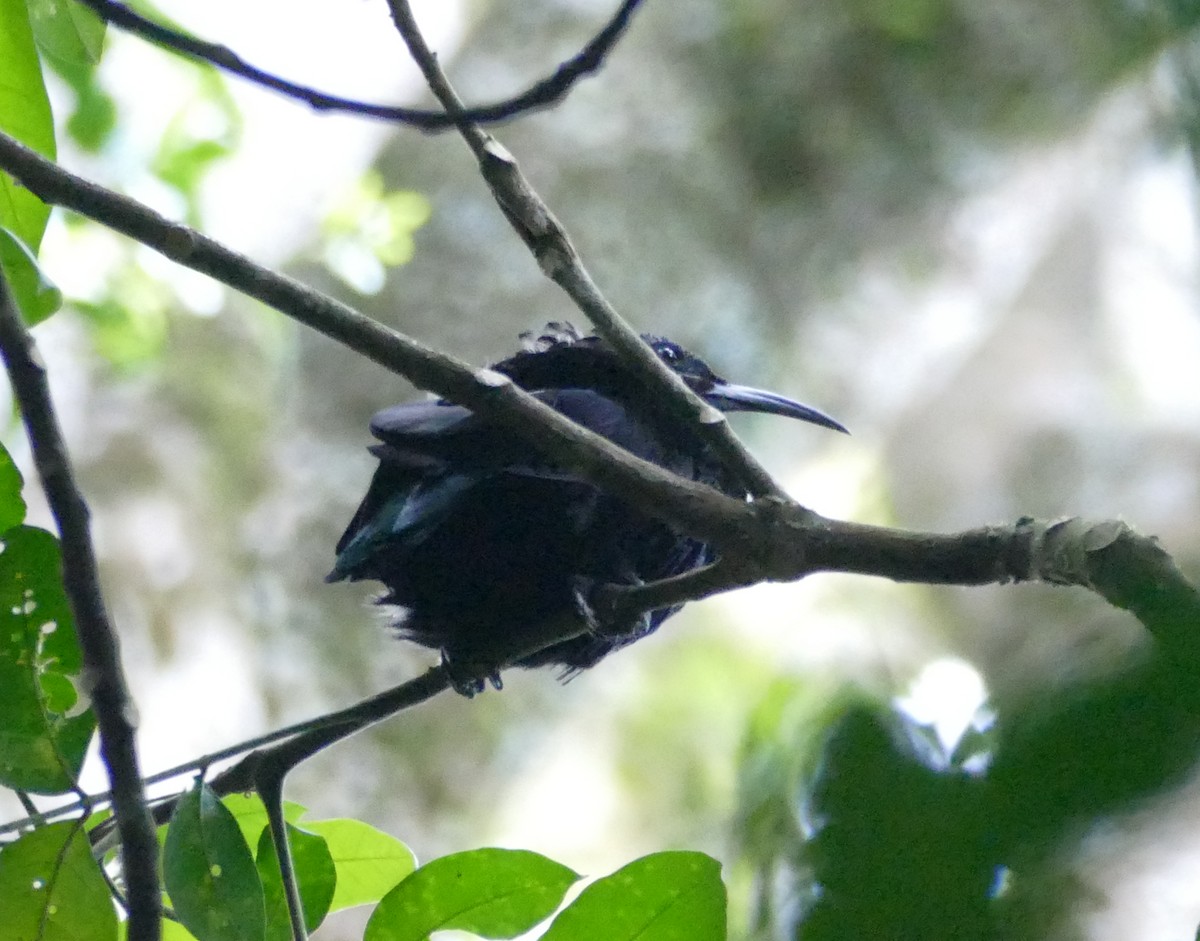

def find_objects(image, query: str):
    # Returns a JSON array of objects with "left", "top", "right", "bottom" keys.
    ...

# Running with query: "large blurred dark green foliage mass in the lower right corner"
[{"left": 736, "top": 658, "right": 1200, "bottom": 941}]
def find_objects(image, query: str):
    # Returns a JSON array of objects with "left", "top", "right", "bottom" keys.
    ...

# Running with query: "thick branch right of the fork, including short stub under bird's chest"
[{"left": 604, "top": 513, "right": 1200, "bottom": 671}]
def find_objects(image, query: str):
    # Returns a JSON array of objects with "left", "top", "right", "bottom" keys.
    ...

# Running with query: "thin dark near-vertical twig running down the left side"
[{"left": 0, "top": 272, "right": 162, "bottom": 941}]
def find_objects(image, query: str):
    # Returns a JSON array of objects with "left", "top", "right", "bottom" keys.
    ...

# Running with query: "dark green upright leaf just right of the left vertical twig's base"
[{"left": 162, "top": 783, "right": 266, "bottom": 941}]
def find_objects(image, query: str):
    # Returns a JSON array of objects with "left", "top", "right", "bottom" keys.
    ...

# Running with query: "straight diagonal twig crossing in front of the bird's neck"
[{"left": 388, "top": 0, "right": 785, "bottom": 497}]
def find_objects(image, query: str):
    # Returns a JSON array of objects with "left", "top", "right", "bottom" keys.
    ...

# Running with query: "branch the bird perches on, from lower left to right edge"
[{"left": 35, "top": 513, "right": 1200, "bottom": 854}]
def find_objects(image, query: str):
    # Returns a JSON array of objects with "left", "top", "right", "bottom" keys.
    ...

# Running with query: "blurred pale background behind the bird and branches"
[{"left": 7, "top": 0, "right": 1200, "bottom": 940}]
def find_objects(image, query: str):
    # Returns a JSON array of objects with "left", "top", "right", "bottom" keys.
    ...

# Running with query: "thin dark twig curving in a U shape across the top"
[{"left": 70, "top": 0, "right": 642, "bottom": 132}]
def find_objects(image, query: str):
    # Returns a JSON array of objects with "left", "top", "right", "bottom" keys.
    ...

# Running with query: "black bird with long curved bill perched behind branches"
[{"left": 326, "top": 323, "right": 845, "bottom": 695}]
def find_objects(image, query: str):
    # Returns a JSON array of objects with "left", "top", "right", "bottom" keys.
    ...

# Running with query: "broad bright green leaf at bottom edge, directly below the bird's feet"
[{"left": 364, "top": 850, "right": 580, "bottom": 941}]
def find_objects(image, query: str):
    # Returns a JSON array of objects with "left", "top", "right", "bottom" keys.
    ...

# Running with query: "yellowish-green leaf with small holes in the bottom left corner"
[{"left": 0, "top": 821, "right": 116, "bottom": 941}]
